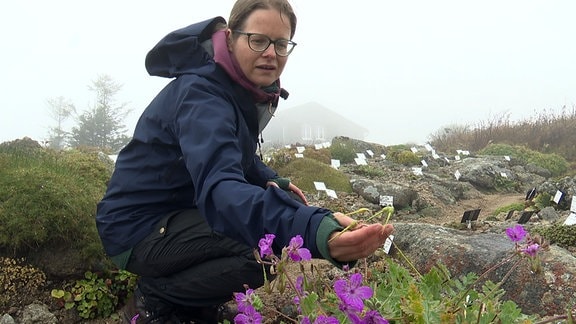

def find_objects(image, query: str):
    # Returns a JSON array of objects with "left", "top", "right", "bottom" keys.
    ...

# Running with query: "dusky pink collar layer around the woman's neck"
[{"left": 212, "top": 30, "right": 281, "bottom": 103}]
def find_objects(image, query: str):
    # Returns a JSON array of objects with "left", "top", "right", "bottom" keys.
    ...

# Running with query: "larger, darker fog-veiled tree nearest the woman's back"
[{"left": 70, "top": 75, "right": 130, "bottom": 152}]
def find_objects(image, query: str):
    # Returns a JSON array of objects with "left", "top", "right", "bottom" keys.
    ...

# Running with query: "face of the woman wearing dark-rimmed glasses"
[{"left": 228, "top": 9, "right": 291, "bottom": 87}]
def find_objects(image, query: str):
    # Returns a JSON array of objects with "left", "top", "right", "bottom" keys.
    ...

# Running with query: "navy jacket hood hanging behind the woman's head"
[{"left": 146, "top": 17, "right": 226, "bottom": 78}]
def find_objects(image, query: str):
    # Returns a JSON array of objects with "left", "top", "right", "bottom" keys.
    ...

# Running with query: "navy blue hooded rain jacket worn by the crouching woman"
[{"left": 96, "top": 17, "right": 330, "bottom": 257}]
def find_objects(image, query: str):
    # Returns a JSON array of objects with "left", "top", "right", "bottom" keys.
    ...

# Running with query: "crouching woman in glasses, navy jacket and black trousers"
[{"left": 97, "top": 0, "right": 392, "bottom": 323}]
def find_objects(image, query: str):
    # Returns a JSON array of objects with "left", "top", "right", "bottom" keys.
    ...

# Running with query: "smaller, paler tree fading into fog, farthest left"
[{"left": 46, "top": 96, "right": 76, "bottom": 150}]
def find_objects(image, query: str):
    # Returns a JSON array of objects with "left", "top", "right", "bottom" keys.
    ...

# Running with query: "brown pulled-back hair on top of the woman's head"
[{"left": 228, "top": 0, "right": 296, "bottom": 39}]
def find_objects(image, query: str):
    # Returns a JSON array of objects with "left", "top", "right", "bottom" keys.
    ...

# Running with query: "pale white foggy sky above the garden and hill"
[{"left": 0, "top": 0, "right": 576, "bottom": 145}]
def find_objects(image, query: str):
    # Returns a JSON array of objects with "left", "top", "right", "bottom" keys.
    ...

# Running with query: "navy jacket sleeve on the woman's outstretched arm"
[{"left": 173, "top": 87, "right": 330, "bottom": 258}]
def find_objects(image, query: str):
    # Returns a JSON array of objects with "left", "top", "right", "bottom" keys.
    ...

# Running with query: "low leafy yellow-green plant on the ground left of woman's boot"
[{"left": 51, "top": 270, "right": 137, "bottom": 319}]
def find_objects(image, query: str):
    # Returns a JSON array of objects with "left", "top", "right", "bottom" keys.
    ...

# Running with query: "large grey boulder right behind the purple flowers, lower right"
[{"left": 392, "top": 223, "right": 576, "bottom": 316}]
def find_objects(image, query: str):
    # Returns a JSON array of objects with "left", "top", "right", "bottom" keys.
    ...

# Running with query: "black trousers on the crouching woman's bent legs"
[{"left": 126, "top": 209, "right": 272, "bottom": 308}]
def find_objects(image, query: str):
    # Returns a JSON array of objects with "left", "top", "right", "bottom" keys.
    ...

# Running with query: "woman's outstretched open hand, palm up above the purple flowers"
[{"left": 328, "top": 213, "right": 394, "bottom": 262}]
